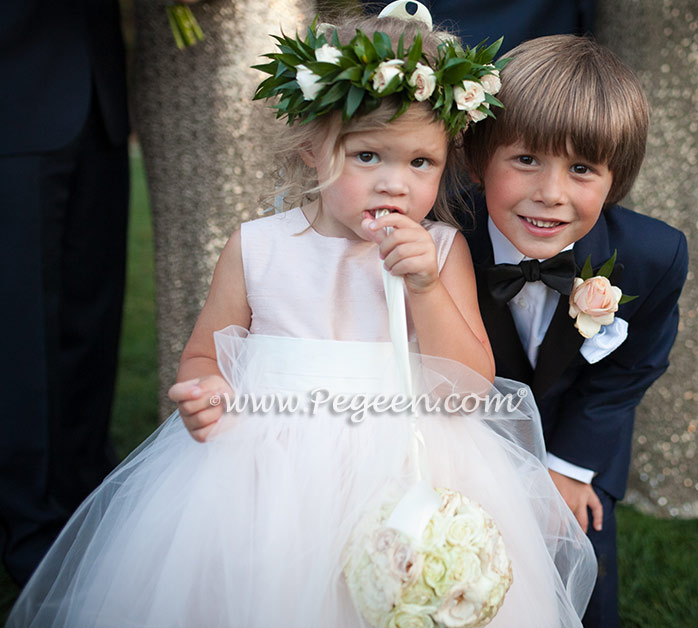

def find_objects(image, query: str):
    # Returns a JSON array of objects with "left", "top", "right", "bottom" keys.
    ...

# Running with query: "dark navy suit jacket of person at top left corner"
[{"left": 0, "top": 0, "right": 128, "bottom": 155}]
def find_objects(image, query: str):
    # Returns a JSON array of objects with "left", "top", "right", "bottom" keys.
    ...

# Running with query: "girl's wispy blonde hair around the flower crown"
[{"left": 265, "top": 16, "right": 467, "bottom": 226}]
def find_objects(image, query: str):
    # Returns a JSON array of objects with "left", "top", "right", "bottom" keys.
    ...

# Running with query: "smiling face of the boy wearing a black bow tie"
[{"left": 480, "top": 143, "right": 613, "bottom": 259}]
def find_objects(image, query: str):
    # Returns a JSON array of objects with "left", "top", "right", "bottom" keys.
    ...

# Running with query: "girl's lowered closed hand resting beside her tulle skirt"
[{"left": 167, "top": 375, "right": 234, "bottom": 443}]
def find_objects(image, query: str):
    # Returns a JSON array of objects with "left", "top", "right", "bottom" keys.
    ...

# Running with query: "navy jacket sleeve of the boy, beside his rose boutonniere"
[{"left": 547, "top": 232, "right": 688, "bottom": 498}]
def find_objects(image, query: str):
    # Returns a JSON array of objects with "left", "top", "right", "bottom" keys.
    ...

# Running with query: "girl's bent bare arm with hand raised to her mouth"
[{"left": 365, "top": 213, "right": 495, "bottom": 381}]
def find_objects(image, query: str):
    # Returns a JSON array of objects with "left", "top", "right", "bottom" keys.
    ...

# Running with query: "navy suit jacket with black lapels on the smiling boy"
[{"left": 464, "top": 205, "right": 688, "bottom": 499}]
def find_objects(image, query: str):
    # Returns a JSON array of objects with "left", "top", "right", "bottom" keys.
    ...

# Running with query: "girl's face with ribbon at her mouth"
[{"left": 304, "top": 114, "right": 448, "bottom": 239}]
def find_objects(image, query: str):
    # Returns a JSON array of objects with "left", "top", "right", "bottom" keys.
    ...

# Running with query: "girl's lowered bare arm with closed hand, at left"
[{"left": 168, "top": 230, "right": 252, "bottom": 442}]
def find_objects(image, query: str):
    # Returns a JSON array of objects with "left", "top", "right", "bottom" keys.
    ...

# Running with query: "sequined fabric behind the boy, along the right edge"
[{"left": 595, "top": 0, "right": 698, "bottom": 517}]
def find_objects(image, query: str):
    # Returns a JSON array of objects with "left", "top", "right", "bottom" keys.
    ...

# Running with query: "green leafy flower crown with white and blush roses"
[{"left": 253, "top": 18, "right": 507, "bottom": 136}]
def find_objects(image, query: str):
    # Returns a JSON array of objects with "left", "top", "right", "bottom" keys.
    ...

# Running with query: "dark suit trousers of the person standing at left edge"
[{"left": 0, "top": 98, "right": 129, "bottom": 584}]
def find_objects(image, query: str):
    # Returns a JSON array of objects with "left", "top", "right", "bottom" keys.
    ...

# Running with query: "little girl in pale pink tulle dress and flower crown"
[{"left": 10, "top": 2, "right": 595, "bottom": 628}]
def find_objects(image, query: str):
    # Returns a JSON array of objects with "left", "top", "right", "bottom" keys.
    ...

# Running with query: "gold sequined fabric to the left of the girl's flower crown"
[{"left": 132, "top": 0, "right": 314, "bottom": 418}]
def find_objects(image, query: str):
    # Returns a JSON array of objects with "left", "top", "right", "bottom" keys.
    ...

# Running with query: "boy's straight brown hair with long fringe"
[{"left": 464, "top": 35, "right": 649, "bottom": 204}]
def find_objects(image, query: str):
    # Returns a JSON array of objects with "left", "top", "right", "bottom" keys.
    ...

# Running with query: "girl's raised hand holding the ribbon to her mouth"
[{"left": 361, "top": 212, "right": 439, "bottom": 293}]
